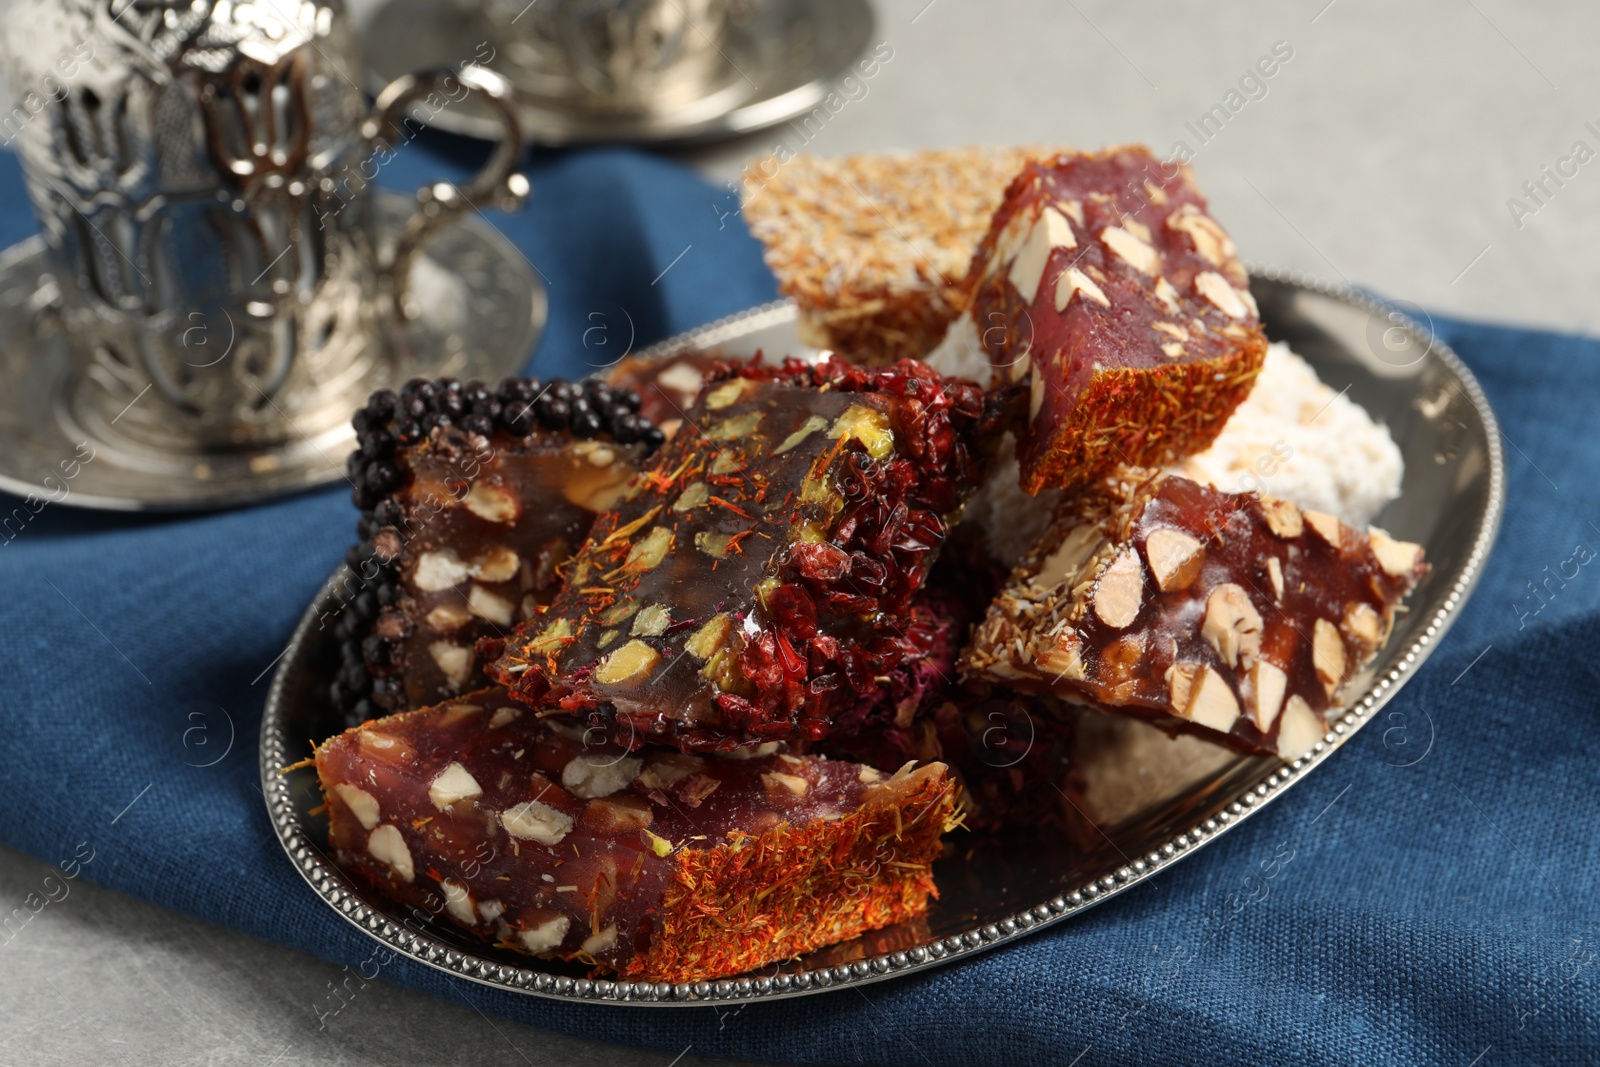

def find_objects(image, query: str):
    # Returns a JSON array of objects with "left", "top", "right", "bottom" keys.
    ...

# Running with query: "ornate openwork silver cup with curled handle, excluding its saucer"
[{"left": 0, "top": 0, "right": 526, "bottom": 454}]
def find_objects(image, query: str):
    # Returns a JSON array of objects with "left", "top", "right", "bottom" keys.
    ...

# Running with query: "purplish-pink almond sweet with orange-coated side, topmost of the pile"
[{"left": 966, "top": 147, "right": 1267, "bottom": 493}]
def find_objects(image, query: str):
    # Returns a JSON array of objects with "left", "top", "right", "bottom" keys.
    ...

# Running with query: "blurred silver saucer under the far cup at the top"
[{"left": 363, "top": 0, "right": 875, "bottom": 146}]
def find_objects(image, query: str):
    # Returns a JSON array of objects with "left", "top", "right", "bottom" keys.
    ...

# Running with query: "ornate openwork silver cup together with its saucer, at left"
[{"left": 0, "top": 0, "right": 544, "bottom": 509}]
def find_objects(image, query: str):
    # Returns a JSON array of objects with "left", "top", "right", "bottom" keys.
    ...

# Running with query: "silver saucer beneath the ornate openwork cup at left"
[{"left": 0, "top": 194, "right": 546, "bottom": 510}]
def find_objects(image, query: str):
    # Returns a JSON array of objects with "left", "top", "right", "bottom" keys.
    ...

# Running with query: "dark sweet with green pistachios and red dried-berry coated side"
[{"left": 491, "top": 360, "right": 997, "bottom": 750}]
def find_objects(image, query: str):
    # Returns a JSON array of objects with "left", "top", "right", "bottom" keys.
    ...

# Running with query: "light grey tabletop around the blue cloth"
[{"left": 9, "top": 0, "right": 1600, "bottom": 1067}]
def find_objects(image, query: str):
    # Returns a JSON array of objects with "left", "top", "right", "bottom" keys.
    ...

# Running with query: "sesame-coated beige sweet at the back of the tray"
[{"left": 742, "top": 147, "right": 1053, "bottom": 365}]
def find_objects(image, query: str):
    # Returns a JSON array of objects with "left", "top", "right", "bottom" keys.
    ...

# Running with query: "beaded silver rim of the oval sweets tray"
[{"left": 261, "top": 267, "right": 1506, "bottom": 1006}]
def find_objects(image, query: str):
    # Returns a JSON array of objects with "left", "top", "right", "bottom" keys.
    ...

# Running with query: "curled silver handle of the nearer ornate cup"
[{"left": 362, "top": 64, "right": 531, "bottom": 322}]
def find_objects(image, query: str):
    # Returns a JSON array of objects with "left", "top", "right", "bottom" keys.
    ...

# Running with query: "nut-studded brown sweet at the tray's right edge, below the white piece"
[{"left": 963, "top": 472, "right": 1427, "bottom": 760}]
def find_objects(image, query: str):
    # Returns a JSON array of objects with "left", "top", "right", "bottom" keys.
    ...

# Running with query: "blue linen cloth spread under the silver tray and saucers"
[{"left": 0, "top": 137, "right": 1600, "bottom": 1067}]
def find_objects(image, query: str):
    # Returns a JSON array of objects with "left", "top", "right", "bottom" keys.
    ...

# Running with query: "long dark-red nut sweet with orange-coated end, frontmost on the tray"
[{"left": 315, "top": 689, "right": 957, "bottom": 982}]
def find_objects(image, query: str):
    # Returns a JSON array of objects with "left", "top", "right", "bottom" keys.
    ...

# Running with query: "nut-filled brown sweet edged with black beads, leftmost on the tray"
[{"left": 333, "top": 378, "right": 662, "bottom": 721}]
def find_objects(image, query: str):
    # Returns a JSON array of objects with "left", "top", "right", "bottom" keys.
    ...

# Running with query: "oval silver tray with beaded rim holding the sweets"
[{"left": 261, "top": 270, "right": 1504, "bottom": 1005}]
